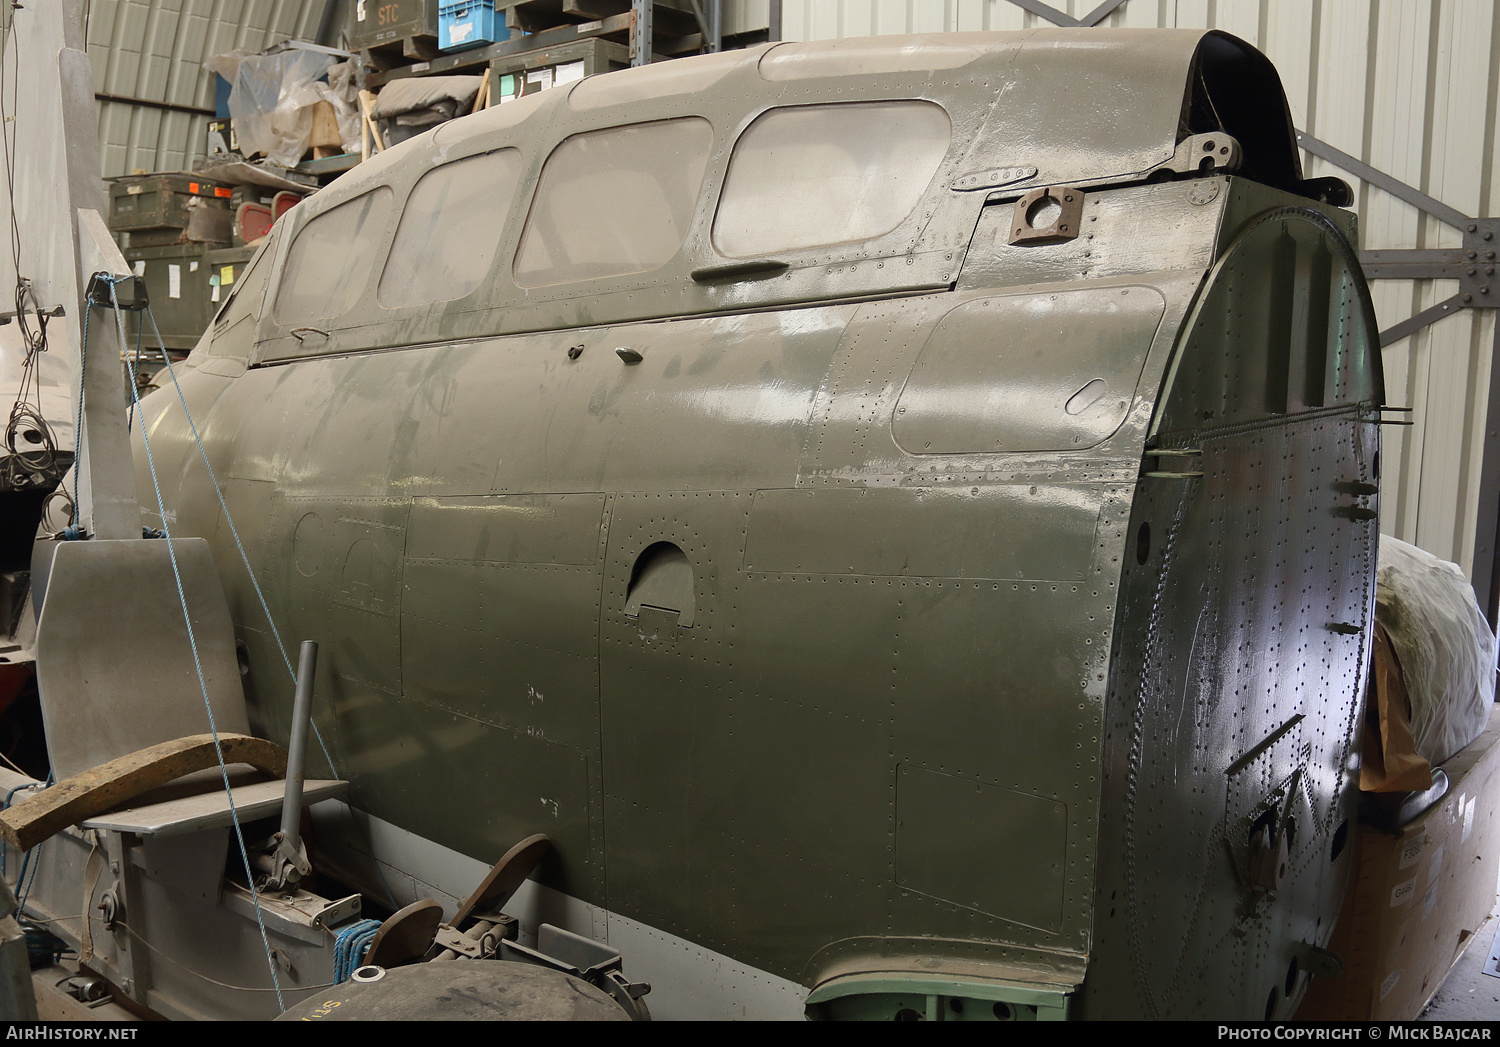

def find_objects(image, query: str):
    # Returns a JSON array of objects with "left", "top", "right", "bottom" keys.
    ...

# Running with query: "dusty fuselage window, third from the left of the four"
[{"left": 516, "top": 117, "right": 714, "bottom": 287}]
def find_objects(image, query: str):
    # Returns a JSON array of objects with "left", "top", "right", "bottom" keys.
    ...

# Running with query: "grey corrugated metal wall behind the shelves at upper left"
[{"left": 85, "top": 0, "right": 324, "bottom": 177}]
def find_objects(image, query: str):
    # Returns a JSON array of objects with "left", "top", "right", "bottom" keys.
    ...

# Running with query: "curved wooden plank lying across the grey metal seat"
[{"left": 0, "top": 735, "right": 287, "bottom": 851}]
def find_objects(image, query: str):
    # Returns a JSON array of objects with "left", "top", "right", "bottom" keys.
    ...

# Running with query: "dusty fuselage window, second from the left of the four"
[{"left": 378, "top": 149, "right": 522, "bottom": 306}]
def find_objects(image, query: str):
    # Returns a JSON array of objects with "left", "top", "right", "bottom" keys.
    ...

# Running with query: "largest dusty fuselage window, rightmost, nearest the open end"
[{"left": 714, "top": 101, "right": 953, "bottom": 258}]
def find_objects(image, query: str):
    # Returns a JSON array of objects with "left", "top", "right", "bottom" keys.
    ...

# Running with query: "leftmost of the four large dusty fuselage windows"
[{"left": 276, "top": 186, "right": 392, "bottom": 324}]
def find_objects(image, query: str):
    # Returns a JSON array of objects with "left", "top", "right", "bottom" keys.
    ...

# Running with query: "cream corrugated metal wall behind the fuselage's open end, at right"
[{"left": 762, "top": 0, "right": 1500, "bottom": 572}]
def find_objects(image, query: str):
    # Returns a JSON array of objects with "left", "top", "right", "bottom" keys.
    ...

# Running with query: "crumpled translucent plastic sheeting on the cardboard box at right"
[{"left": 1376, "top": 536, "right": 1496, "bottom": 767}]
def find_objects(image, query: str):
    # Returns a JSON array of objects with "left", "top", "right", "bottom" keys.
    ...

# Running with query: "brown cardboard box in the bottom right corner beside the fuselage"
[{"left": 1296, "top": 710, "right": 1500, "bottom": 1020}]
